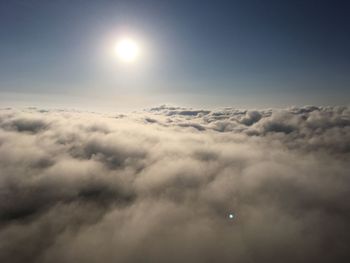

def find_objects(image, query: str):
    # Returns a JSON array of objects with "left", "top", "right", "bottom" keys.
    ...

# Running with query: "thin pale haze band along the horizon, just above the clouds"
[{"left": 0, "top": 91, "right": 350, "bottom": 113}]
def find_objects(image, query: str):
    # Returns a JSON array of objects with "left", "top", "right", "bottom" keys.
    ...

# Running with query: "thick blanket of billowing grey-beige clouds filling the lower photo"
[{"left": 0, "top": 106, "right": 350, "bottom": 263}]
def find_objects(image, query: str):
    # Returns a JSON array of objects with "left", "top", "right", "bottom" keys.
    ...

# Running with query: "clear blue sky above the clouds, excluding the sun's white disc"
[{"left": 0, "top": 0, "right": 350, "bottom": 108}]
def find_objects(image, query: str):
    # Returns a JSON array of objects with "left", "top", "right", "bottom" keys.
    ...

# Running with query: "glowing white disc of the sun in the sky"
[{"left": 115, "top": 38, "right": 140, "bottom": 63}]
